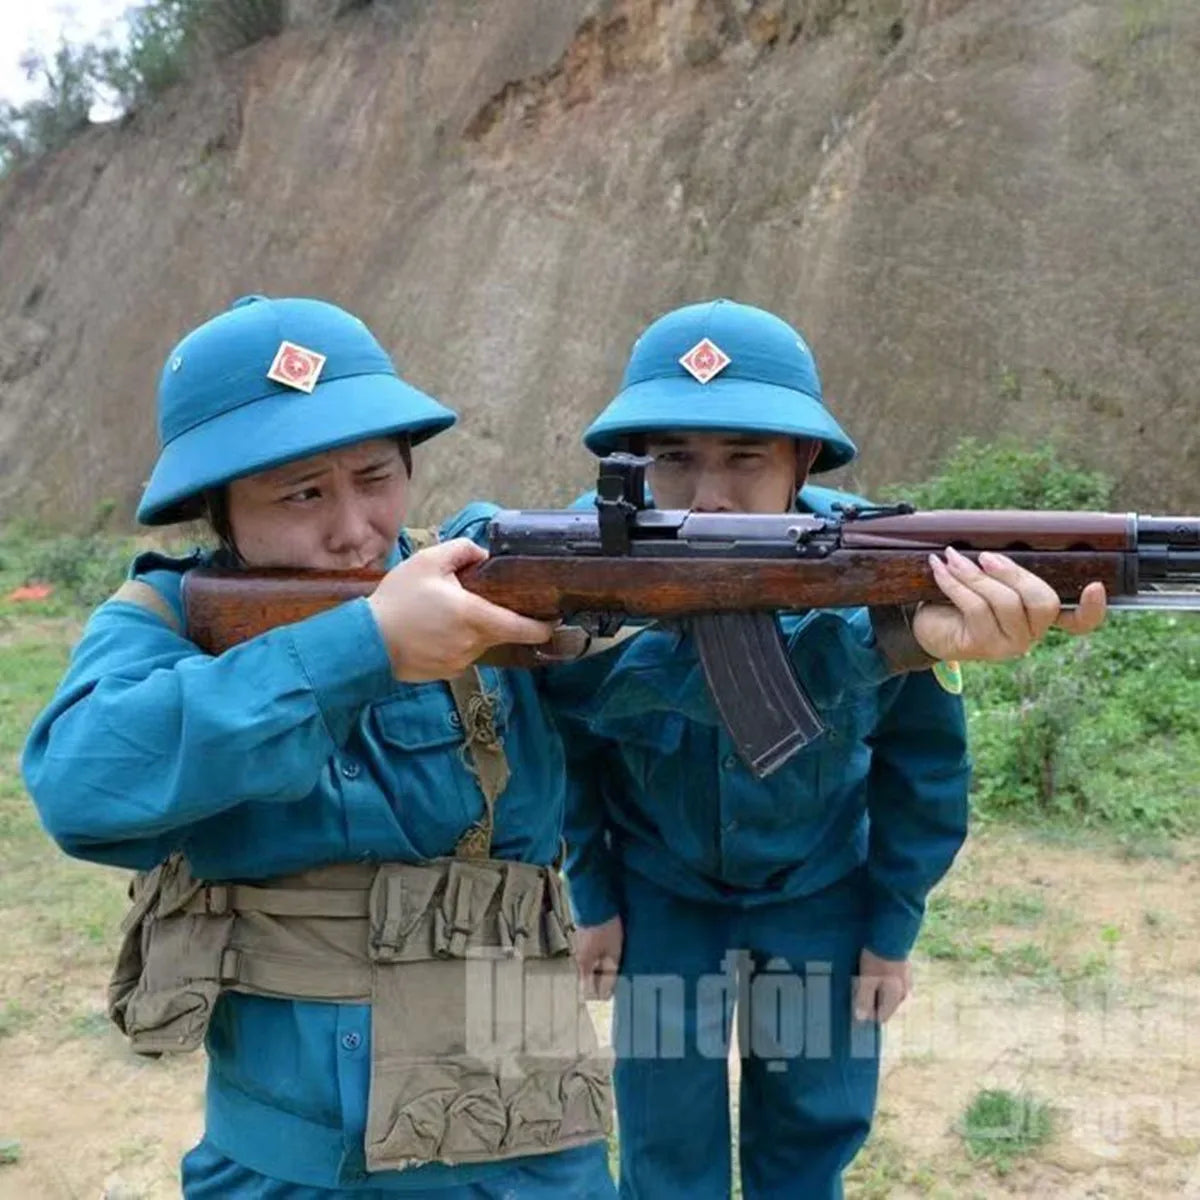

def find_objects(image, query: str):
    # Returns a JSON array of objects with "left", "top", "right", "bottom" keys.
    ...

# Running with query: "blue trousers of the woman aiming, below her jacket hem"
[{"left": 182, "top": 1141, "right": 617, "bottom": 1200}]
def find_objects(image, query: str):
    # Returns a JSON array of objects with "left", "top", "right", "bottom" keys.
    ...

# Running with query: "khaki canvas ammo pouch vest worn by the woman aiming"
[{"left": 108, "top": 539, "right": 612, "bottom": 1171}]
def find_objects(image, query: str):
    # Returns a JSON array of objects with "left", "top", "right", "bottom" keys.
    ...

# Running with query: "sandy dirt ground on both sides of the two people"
[{"left": 0, "top": 833, "right": 1200, "bottom": 1200}]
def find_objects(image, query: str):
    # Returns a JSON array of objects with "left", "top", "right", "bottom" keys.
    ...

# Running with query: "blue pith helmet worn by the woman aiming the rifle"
[{"left": 138, "top": 295, "right": 456, "bottom": 526}]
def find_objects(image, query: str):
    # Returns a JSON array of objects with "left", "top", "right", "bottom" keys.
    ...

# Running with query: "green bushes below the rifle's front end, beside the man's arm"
[{"left": 966, "top": 613, "right": 1200, "bottom": 834}]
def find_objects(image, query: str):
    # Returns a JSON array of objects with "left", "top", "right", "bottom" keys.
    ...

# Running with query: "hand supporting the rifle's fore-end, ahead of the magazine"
[{"left": 912, "top": 548, "right": 1106, "bottom": 661}]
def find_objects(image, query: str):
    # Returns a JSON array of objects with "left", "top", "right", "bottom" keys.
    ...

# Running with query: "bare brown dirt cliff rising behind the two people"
[{"left": 0, "top": 0, "right": 1200, "bottom": 523}]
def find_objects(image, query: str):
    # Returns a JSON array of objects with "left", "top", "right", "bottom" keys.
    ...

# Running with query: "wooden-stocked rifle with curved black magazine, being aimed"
[{"left": 184, "top": 455, "right": 1200, "bottom": 778}]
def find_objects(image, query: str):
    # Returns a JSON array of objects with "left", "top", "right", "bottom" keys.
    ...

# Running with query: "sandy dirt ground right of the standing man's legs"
[{"left": 864, "top": 838, "right": 1200, "bottom": 1200}]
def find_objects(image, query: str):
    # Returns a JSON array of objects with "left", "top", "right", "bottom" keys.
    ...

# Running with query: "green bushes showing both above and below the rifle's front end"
[{"left": 892, "top": 439, "right": 1200, "bottom": 836}]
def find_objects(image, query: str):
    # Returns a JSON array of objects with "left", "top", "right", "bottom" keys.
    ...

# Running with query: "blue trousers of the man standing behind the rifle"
[{"left": 613, "top": 871, "right": 880, "bottom": 1200}]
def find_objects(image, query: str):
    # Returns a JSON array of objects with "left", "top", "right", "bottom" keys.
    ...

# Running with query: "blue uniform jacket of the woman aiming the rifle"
[{"left": 22, "top": 505, "right": 576, "bottom": 1190}]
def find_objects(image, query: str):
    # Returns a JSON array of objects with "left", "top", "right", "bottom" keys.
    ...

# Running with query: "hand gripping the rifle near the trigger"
[{"left": 367, "top": 538, "right": 553, "bottom": 683}]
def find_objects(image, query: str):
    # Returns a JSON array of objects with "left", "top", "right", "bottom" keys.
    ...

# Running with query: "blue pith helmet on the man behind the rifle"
[{"left": 583, "top": 300, "right": 858, "bottom": 472}]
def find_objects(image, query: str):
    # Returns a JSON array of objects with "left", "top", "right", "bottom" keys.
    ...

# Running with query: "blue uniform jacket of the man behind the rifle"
[{"left": 552, "top": 487, "right": 970, "bottom": 959}]
